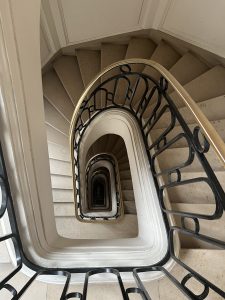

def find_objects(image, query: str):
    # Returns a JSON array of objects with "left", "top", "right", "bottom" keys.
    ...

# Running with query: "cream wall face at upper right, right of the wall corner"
[{"left": 156, "top": 0, "right": 225, "bottom": 57}]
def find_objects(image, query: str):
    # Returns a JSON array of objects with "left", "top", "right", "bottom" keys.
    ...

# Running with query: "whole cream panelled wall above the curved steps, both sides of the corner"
[{"left": 41, "top": 0, "right": 225, "bottom": 64}]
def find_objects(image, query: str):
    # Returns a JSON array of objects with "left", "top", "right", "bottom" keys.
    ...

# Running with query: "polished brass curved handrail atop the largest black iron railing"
[{"left": 70, "top": 58, "right": 225, "bottom": 166}]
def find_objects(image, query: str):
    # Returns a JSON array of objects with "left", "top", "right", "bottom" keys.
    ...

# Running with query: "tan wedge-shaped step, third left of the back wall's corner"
[{"left": 76, "top": 49, "right": 101, "bottom": 87}]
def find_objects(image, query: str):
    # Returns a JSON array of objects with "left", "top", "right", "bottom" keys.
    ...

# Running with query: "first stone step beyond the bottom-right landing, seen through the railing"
[{"left": 172, "top": 203, "right": 225, "bottom": 249}]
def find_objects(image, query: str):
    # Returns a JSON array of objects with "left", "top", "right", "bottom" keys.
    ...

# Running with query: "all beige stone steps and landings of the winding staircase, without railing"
[{"left": 1, "top": 38, "right": 225, "bottom": 300}]
